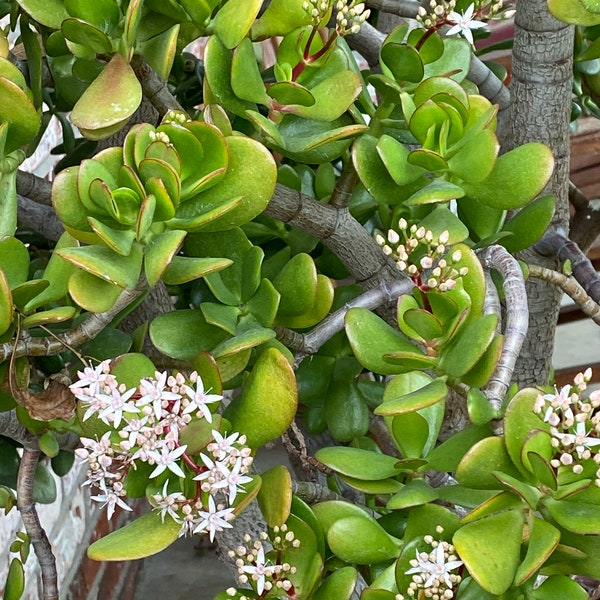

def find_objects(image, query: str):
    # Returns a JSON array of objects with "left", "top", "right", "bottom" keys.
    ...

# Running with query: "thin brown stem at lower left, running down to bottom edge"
[{"left": 17, "top": 447, "right": 58, "bottom": 600}]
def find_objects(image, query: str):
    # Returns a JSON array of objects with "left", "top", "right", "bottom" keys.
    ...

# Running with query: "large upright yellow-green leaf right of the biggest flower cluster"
[{"left": 224, "top": 348, "right": 298, "bottom": 448}]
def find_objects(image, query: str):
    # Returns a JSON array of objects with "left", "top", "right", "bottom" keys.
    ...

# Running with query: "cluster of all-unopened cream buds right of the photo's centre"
[{"left": 375, "top": 219, "right": 468, "bottom": 292}]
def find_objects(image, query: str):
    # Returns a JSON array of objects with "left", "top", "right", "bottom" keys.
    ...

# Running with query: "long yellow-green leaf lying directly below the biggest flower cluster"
[{"left": 87, "top": 511, "right": 181, "bottom": 561}]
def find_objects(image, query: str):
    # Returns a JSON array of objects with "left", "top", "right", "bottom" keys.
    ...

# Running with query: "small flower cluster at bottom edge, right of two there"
[{"left": 396, "top": 526, "right": 463, "bottom": 600}]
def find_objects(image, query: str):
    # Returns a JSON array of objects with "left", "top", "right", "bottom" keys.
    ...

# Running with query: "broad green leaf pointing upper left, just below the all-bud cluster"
[{"left": 345, "top": 308, "right": 424, "bottom": 375}]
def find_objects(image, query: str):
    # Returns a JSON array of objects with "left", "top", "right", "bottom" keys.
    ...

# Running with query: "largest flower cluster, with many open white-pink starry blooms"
[{"left": 70, "top": 361, "right": 252, "bottom": 541}]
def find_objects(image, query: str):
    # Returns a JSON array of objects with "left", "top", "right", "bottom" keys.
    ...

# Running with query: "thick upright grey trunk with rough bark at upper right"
[{"left": 504, "top": 0, "right": 573, "bottom": 385}]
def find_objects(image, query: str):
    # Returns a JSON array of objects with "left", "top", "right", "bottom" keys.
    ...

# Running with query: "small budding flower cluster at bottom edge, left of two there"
[{"left": 227, "top": 524, "right": 300, "bottom": 600}]
